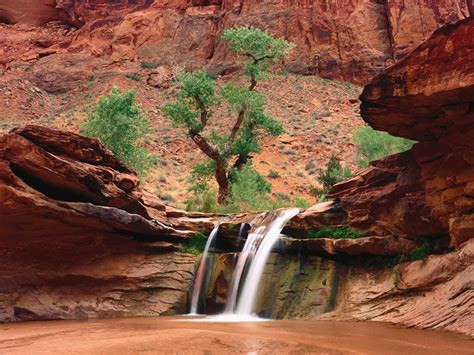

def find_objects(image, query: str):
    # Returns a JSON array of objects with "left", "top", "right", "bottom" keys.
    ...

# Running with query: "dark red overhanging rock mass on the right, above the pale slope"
[{"left": 330, "top": 19, "right": 474, "bottom": 246}]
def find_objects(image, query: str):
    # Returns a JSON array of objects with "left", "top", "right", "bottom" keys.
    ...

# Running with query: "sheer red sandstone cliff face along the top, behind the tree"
[{"left": 0, "top": 0, "right": 472, "bottom": 83}]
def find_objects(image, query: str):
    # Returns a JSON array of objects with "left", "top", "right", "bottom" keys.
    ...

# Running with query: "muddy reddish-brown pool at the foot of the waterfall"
[{"left": 0, "top": 317, "right": 474, "bottom": 355}]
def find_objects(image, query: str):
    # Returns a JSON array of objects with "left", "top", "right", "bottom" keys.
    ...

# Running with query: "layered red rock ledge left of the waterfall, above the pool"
[{"left": 0, "top": 126, "right": 212, "bottom": 321}]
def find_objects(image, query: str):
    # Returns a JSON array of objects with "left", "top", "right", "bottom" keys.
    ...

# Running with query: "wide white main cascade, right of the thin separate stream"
[{"left": 226, "top": 208, "right": 299, "bottom": 316}]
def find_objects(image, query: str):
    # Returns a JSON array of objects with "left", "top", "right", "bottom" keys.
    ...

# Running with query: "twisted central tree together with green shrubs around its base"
[{"left": 162, "top": 27, "right": 292, "bottom": 209}]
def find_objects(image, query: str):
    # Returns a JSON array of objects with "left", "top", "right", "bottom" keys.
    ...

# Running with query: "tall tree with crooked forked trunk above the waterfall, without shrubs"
[{"left": 162, "top": 27, "right": 292, "bottom": 204}]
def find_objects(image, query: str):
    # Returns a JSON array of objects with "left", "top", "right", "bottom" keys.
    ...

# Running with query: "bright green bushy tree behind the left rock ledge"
[{"left": 81, "top": 88, "right": 156, "bottom": 178}]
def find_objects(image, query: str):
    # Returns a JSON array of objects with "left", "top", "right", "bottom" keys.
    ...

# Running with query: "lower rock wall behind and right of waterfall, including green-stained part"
[{"left": 201, "top": 240, "right": 474, "bottom": 336}]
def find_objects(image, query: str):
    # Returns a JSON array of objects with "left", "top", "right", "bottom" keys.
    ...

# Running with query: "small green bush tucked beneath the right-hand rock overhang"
[{"left": 353, "top": 127, "right": 415, "bottom": 167}]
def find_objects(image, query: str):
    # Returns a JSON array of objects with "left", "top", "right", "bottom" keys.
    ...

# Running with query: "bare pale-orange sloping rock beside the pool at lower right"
[{"left": 320, "top": 239, "right": 474, "bottom": 336}]
